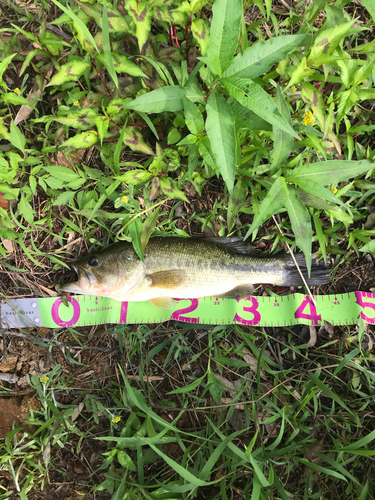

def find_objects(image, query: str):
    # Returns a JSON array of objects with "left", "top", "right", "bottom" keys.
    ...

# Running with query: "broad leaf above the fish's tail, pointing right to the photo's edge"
[{"left": 288, "top": 160, "right": 375, "bottom": 186}]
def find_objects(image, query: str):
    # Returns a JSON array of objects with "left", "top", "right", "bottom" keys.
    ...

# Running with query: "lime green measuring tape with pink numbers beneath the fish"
[{"left": 0, "top": 292, "right": 375, "bottom": 328}]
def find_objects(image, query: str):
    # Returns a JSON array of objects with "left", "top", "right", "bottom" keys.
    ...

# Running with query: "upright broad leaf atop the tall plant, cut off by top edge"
[{"left": 204, "top": 0, "right": 242, "bottom": 76}]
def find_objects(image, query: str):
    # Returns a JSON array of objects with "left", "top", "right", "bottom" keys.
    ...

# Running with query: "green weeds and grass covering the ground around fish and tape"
[{"left": 0, "top": 0, "right": 375, "bottom": 500}]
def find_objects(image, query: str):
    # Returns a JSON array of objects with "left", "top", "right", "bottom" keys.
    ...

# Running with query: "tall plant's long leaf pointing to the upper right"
[{"left": 223, "top": 34, "right": 306, "bottom": 78}]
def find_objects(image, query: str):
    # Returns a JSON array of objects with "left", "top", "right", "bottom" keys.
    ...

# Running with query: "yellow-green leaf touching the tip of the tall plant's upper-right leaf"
[{"left": 307, "top": 19, "right": 355, "bottom": 66}]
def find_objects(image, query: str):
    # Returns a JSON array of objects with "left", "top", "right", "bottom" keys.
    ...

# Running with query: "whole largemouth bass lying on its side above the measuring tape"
[{"left": 61, "top": 237, "right": 331, "bottom": 309}]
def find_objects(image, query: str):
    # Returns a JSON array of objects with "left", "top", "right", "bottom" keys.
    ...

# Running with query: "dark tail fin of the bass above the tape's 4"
[{"left": 283, "top": 253, "right": 331, "bottom": 286}]
